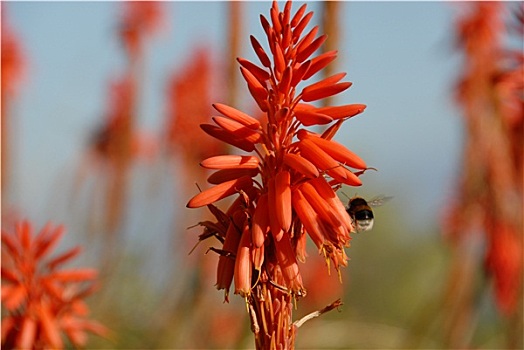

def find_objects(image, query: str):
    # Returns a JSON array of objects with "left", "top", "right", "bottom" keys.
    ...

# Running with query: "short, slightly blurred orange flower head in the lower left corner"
[{"left": 2, "top": 222, "right": 108, "bottom": 349}]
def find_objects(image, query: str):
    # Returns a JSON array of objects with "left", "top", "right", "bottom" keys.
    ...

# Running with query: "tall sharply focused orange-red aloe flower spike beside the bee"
[{"left": 187, "top": 2, "right": 366, "bottom": 348}]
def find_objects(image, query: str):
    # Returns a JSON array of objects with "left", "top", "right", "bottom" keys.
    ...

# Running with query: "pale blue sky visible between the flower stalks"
[{"left": 2, "top": 2, "right": 461, "bottom": 234}]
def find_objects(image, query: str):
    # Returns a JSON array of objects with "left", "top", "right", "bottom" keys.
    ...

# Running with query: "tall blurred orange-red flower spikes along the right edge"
[{"left": 438, "top": 2, "right": 524, "bottom": 348}]
